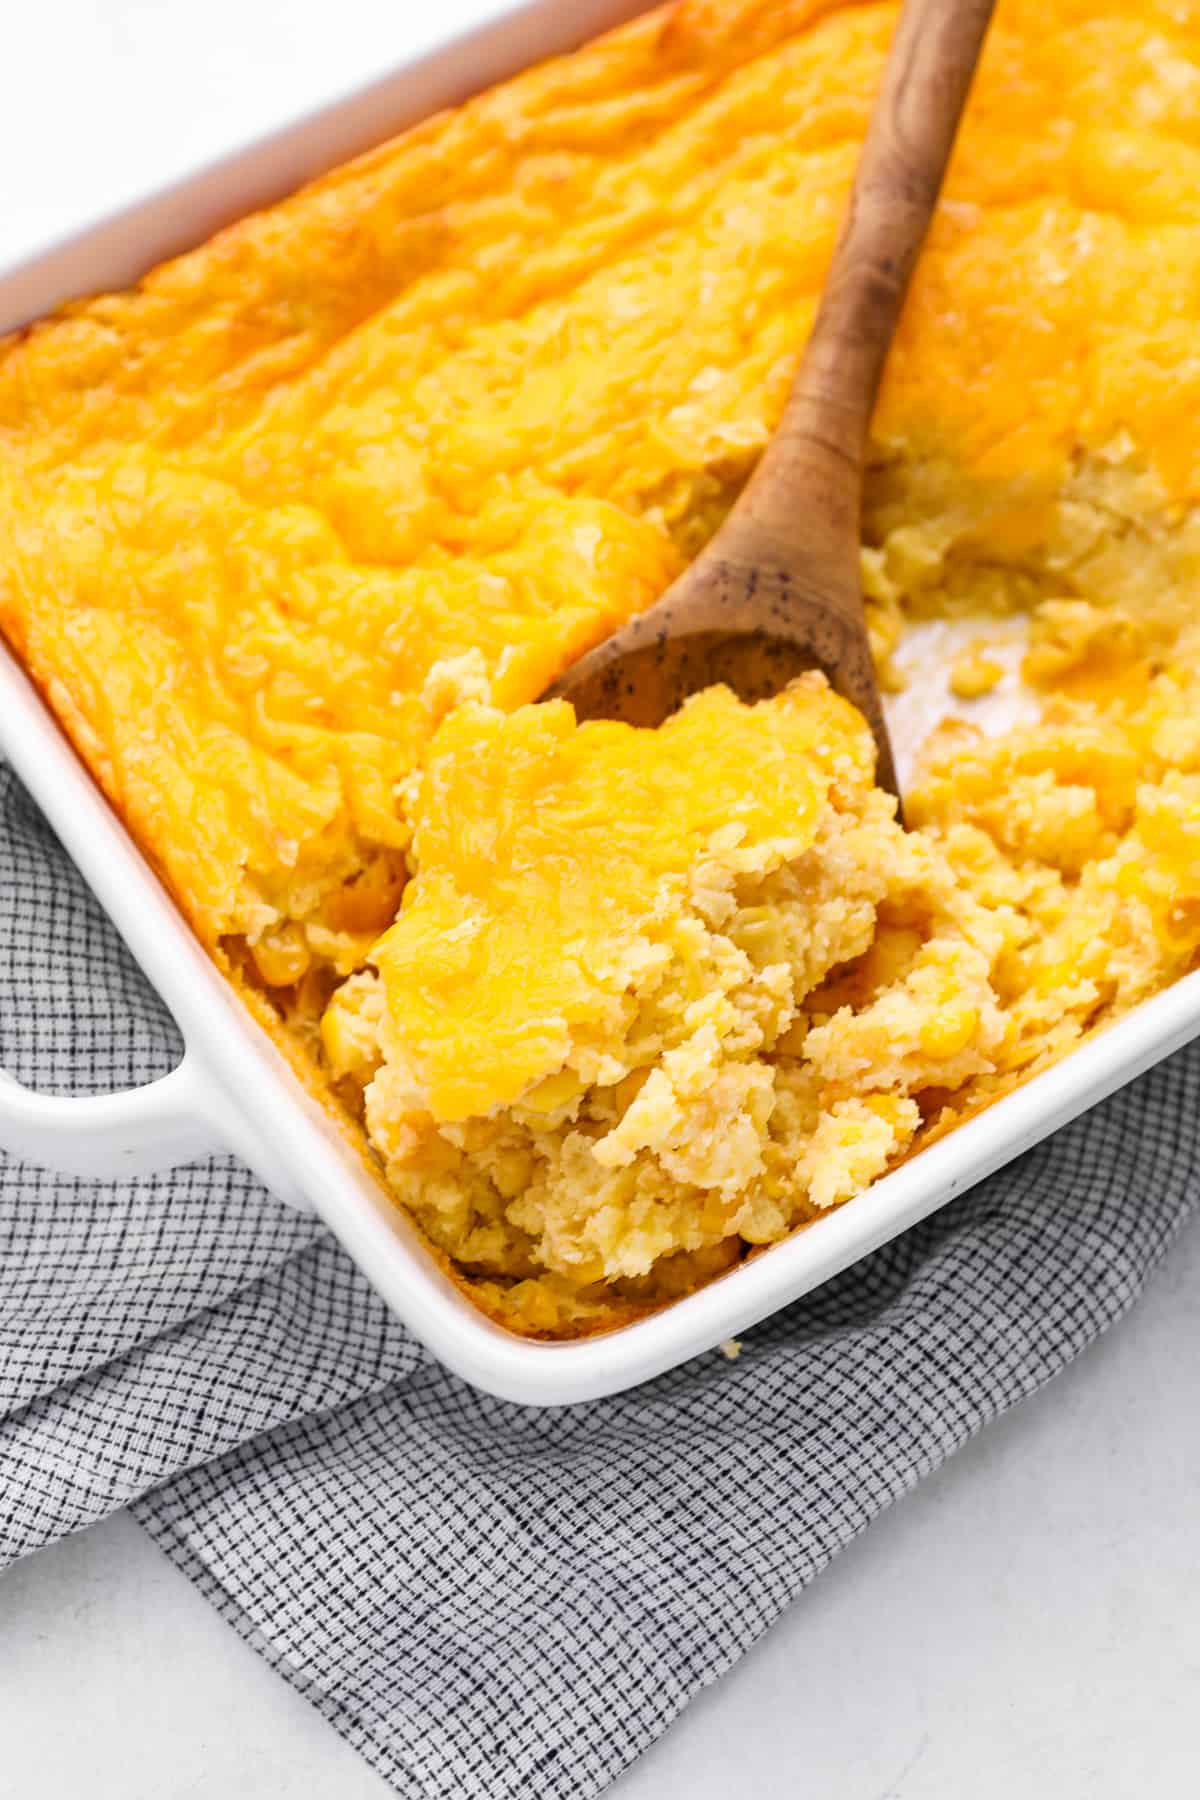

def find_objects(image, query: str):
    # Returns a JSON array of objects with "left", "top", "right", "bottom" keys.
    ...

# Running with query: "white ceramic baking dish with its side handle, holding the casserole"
[{"left": 0, "top": 0, "right": 1200, "bottom": 1404}]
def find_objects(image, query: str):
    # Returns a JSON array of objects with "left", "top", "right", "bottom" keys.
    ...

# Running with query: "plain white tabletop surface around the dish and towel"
[{"left": 0, "top": 0, "right": 1200, "bottom": 1800}]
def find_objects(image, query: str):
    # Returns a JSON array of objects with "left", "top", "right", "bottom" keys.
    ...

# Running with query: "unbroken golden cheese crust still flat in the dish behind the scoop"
[{"left": 0, "top": 0, "right": 1200, "bottom": 985}]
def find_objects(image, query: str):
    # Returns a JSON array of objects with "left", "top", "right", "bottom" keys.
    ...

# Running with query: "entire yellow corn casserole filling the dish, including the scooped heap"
[{"left": 0, "top": 0, "right": 1200, "bottom": 1336}]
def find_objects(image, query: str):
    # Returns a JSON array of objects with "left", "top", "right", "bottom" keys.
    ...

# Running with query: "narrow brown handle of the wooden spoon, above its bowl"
[{"left": 738, "top": 0, "right": 995, "bottom": 576}]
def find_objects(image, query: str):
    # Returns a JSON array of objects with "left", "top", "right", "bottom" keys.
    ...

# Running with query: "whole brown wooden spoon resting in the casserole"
[{"left": 551, "top": 0, "right": 993, "bottom": 797}]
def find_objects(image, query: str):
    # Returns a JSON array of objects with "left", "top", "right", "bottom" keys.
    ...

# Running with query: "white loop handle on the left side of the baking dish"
[{"left": 0, "top": 1051, "right": 237, "bottom": 1181}]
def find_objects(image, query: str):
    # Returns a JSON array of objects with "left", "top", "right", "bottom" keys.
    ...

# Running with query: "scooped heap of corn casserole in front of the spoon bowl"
[{"left": 322, "top": 675, "right": 1011, "bottom": 1325}]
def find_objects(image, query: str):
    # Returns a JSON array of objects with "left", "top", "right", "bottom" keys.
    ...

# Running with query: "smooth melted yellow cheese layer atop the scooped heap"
[{"left": 371, "top": 689, "right": 871, "bottom": 1120}]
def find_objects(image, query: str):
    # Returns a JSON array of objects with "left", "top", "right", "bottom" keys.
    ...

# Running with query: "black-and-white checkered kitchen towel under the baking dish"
[{"left": 0, "top": 770, "right": 1200, "bottom": 1800}]
